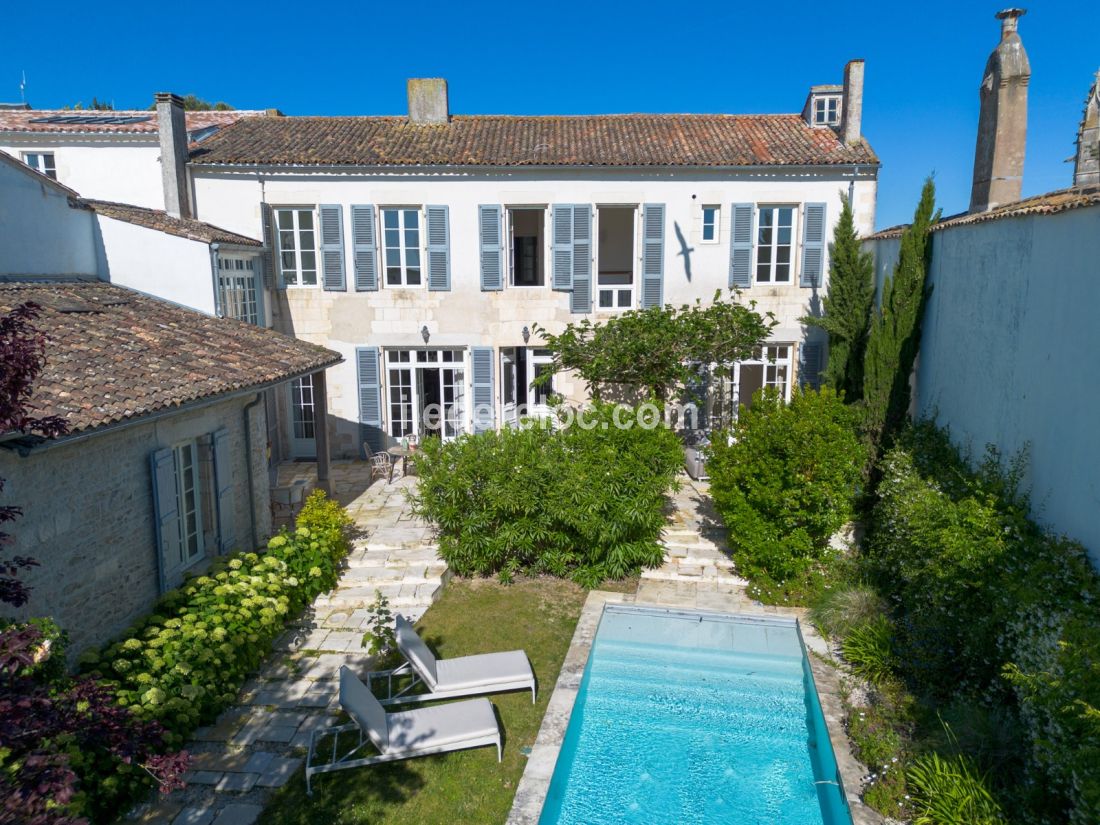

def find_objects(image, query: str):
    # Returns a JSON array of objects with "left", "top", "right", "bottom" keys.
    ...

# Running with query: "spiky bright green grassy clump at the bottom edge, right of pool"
[{"left": 905, "top": 754, "right": 1007, "bottom": 825}]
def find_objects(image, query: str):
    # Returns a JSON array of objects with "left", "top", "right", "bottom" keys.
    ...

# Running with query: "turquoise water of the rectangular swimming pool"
[{"left": 539, "top": 605, "right": 851, "bottom": 825}]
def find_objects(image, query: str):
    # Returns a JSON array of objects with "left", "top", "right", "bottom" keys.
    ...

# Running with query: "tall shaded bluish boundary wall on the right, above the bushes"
[{"left": 917, "top": 207, "right": 1100, "bottom": 564}]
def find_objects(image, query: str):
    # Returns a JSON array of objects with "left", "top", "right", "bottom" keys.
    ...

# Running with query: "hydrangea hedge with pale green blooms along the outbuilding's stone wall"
[{"left": 85, "top": 492, "right": 350, "bottom": 744}]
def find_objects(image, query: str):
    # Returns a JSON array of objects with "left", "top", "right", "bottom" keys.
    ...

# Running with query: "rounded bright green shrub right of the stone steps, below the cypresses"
[{"left": 707, "top": 388, "right": 867, "bottom": 602}]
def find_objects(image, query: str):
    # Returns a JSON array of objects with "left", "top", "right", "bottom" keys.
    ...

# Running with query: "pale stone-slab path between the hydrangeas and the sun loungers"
[{"left": 125, "top": 462, "right": 449, "bottom": 825}]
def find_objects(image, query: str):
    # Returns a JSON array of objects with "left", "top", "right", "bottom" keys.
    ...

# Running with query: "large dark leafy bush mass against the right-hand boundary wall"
[{"left": 865, "top": 422, "right": 1100, "bottom": 825}]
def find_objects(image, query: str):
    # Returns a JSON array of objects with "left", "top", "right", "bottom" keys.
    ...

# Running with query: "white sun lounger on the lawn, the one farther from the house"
[{"left": 306, "top": 666, "right": 502, "bottom": 795}]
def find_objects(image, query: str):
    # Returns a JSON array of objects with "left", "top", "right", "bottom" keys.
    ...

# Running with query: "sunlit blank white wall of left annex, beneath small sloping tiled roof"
[{"left": 98, "top": 216, "right": 216, "bottom": 315}]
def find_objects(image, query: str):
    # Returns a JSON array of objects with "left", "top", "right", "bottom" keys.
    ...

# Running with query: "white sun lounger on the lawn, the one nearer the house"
[{"left": 367, "top": 616, "right": 536, "bottom": 705}]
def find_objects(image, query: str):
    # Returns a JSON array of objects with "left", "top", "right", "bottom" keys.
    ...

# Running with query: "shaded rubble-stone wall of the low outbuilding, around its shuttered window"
[{"left": 0, "top": 396, "right": 271, "bottom": 657}]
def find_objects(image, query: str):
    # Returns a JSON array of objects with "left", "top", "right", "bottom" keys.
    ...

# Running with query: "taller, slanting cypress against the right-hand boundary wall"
[{"left": 864, "top": 177, "right": 939, "bottom": 451}]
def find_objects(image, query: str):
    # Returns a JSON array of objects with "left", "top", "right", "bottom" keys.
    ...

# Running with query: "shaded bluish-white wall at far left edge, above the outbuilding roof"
[{"left": 0, "top": 163, "right": 98, "bottom": 276}]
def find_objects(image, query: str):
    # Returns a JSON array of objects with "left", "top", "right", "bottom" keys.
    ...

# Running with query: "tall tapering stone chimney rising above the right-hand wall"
[{"left": 970, "top": 9, "right": 1031, "bottom": 212}]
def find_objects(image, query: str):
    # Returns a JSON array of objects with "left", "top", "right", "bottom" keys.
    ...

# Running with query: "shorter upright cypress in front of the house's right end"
[{"left": 802, "top": 198, "right": 875, "bottom": 404}]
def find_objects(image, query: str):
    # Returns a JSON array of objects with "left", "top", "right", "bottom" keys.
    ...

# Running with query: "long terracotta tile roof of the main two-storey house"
[{"left": 191, "top": 114, "right": 878, "bottom": 167}]
